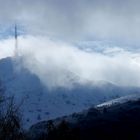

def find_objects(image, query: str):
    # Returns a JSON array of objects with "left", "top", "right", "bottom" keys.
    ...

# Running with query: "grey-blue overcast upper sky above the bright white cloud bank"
[{"left": 0, "top": 0, "right": 140, "bottom": 45}]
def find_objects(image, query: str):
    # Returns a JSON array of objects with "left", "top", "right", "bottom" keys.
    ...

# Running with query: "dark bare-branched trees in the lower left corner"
[{"left": 0, "top": 81, "right": 25, "bottom": 140}]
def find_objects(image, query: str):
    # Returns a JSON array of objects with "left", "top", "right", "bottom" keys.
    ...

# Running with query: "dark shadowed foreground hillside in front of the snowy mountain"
[{"left": 28, "top": 95, "right": 140, "bottom": 140}]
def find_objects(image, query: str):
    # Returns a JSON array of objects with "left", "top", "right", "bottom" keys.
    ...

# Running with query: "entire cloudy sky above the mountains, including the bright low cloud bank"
[{"left": 0, "top": 0, "right": 140, "bottom": 87}]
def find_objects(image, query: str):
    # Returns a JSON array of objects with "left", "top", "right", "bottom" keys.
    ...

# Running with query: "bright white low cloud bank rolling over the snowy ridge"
[{"left": 0, "top": 36, "right": 140, "bottom": 88}]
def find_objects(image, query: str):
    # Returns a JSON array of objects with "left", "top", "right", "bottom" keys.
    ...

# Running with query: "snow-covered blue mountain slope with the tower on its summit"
[{"left": 0, "top": 57, "right": 140, "bottom": 128}]
